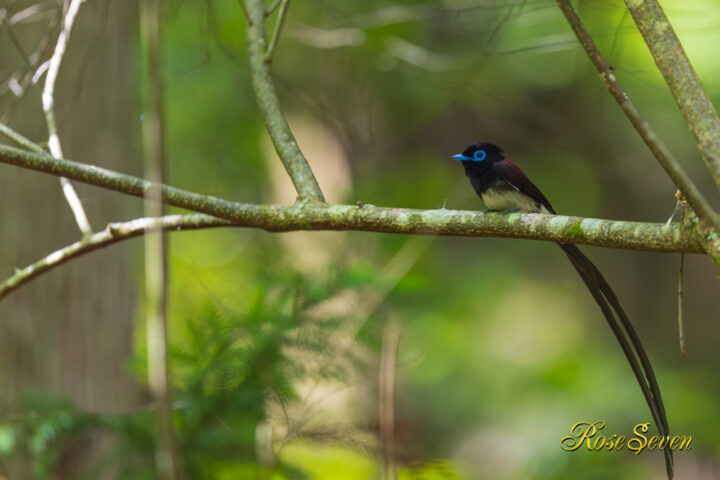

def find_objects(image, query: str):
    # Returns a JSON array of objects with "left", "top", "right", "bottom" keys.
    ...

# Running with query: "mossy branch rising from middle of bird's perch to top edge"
[{"left": 245, "top": 0, "right": 325, "bottom": 202}]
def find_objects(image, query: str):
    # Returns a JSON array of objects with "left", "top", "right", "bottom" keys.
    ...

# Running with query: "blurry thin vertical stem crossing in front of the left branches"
[{"left": 142, "top": 0, "right": 182, "bottom": 480}]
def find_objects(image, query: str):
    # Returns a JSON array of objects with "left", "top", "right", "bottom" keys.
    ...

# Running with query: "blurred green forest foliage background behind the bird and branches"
[{"left": 0, "top": 0, "right": 720, "bottom": 479}]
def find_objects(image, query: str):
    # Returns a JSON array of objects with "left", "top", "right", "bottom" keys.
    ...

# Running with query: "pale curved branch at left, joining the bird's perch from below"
[{"left": 0, "top": 217, "right": 232, "bottom": 299}]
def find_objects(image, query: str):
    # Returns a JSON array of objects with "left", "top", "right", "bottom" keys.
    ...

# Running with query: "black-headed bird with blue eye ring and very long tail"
[{"left": 451, "top": 142, "right": 673, "bottom": 480}]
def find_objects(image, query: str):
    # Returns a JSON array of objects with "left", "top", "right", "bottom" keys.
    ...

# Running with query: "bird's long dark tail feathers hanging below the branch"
[{"left": 558, "top": 244, "right": 673, "bottom": 480}]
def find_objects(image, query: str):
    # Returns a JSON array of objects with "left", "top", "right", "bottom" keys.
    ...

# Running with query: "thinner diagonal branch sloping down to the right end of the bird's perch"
[{"left": 557, "top": 0, "right": 720, "bottom": 253}]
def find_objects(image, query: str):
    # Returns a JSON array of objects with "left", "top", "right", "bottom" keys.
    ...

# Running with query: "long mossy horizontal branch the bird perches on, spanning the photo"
[{"left": 0, "top": 145, "right": 704, "bottom": 253}]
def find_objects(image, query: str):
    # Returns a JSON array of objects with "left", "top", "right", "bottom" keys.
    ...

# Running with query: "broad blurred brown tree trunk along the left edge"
[{"left": 0, "top": 0, "right": 142, "bottom": 478}]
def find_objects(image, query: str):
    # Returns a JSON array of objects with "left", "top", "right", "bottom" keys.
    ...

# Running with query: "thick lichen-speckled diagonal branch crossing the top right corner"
[{"left": 625, "top": 0, "right": 720, "bottom": 189}]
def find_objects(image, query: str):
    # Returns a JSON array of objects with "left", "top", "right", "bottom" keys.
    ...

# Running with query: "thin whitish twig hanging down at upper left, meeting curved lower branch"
[{"left": 42, "top": 0, "right": 92, "bottom": 235}]
